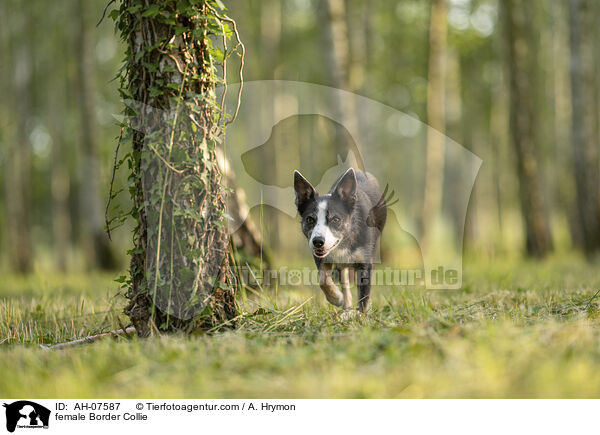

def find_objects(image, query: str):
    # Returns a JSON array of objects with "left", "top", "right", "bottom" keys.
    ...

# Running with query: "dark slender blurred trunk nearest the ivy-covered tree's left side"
[{"left": 75, "top": 0, "right": 116, "bottom": 269}]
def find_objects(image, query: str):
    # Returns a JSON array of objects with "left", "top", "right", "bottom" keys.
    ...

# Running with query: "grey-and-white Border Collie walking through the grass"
[{"left": 294, "top": 168, "right": 387, "bottom": 313}]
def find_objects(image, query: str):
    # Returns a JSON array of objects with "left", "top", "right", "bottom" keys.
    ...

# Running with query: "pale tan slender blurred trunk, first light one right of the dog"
[{"left": 422, "top": 0, "right": 448, "bottom": 243}]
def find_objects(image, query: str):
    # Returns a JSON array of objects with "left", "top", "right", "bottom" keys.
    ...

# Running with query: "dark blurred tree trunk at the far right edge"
[{"left": 569, "top": 0, "right": 600, "bottom": 255}]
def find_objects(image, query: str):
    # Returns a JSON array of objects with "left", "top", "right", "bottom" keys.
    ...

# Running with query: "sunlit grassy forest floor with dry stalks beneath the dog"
[{"left": 0, "top": 257, "right": 600, "bottom": 398}]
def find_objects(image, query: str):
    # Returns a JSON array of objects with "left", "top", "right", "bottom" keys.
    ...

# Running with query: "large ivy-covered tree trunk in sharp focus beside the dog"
[{"left": 117, "top": 0, "right": 237, "bottom": 336}]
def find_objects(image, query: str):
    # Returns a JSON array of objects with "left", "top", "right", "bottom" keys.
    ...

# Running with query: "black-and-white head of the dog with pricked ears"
[{"left": 294, "top": 168, "right": 356, "bottom": 258}]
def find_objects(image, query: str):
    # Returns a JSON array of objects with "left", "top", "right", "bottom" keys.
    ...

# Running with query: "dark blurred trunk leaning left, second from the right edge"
[{"left": 502, "top": 0, "right": 552, "bottom": 257}]
